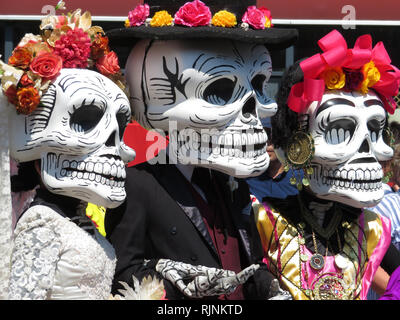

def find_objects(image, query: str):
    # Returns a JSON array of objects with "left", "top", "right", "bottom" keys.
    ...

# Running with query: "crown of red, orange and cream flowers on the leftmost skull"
[{"left": 0, "top": 4, "right": 126, "bottom": 115}]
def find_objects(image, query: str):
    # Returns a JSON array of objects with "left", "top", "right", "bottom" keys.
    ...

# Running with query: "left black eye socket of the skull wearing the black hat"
[{"left": 203, "top": 78, "right": 237, "bottom": 106}]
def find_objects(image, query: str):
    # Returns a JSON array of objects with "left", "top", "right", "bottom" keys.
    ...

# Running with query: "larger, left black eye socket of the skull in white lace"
[{"left": 70, "top": 105, "right": 104, "bottom": 132}]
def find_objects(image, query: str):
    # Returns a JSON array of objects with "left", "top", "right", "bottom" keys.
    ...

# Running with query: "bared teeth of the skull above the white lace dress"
[{"left": 60, "top": 158, "right": 126, "bottom": 188}]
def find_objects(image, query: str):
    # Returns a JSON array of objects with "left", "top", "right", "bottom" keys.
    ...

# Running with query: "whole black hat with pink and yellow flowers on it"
[{"left": 107, "top": 0, "right": 298, "bottom": 50}]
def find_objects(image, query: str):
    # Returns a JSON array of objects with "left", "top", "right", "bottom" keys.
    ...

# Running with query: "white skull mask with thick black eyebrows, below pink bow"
[{"left": 307, "top": 91, "right": 393, "bottom": 208}]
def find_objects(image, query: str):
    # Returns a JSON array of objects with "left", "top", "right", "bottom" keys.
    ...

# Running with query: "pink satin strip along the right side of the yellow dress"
[{"left": 360, "top": 213, "right": 391, "bottom": 300}]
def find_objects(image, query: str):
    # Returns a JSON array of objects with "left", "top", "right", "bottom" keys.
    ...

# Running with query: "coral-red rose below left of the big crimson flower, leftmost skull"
[{"left": 30, "top": 52, "right": 63, "bottom": 80}]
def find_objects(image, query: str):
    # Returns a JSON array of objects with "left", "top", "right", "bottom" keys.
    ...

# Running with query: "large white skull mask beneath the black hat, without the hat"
[{"left": 126, "top": 40, "right": 277, "bottom": 177}]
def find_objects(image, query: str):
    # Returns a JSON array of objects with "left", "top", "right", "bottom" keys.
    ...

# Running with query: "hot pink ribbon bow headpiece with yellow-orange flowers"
[{"left": 288, "top": 30, "right": 400, "bottom": 114}]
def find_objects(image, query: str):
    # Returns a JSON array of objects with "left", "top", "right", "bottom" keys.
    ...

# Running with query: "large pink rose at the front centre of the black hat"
[{"left": 174, "top": 0, "right": 211, "bottom": 27}]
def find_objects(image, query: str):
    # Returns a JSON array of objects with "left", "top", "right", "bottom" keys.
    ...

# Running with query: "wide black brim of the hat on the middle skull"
[{"left": 106, "top": 25, "right": 298, "bottom": 50}]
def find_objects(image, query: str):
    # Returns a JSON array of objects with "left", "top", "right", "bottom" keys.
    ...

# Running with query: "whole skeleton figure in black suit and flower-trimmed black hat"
[{"left": 105, "top": 0, "right": 297, "bottom": 299}]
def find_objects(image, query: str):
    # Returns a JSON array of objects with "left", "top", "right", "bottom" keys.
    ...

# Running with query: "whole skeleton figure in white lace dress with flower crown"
[{"left": 0, "top": 10, "right": 135, "bottom": 300}]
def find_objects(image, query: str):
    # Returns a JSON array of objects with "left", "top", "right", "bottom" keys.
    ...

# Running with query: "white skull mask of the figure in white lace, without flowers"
[{"left": 11, "top": 69, "right": 135, "bottom": 208}]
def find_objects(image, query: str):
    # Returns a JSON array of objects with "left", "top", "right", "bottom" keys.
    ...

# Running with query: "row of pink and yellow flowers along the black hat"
[{"left": 125, "top": 0, "right": 273, "bottom": 29}]
